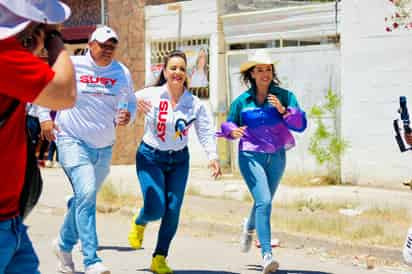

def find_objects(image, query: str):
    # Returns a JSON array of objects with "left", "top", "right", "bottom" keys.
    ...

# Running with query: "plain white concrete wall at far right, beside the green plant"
[{"left": 341, "top": 0, "right": 412, "bottom": 187}]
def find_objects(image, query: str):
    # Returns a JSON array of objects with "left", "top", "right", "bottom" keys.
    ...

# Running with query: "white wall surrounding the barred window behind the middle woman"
[{"left": 145, "top": 0, "right": 224, "bottom": 166}]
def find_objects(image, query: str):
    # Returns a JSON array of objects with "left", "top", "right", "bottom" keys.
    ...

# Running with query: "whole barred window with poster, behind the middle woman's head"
[{"left": 150, "top": 38, "right": 209, "bottom": 98}]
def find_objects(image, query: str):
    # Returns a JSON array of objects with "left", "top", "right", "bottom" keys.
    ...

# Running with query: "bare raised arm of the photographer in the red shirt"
[{"left": 33, "top": 36, "right": 77, "bottom": 110}]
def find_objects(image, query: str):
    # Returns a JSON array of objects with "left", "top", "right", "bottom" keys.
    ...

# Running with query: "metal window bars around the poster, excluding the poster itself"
[{"left": 150, "top": 38, "right": 209, "bottom": 98}]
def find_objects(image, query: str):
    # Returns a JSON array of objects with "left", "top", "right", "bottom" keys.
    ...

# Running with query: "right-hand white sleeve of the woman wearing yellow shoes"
[{"left": 194, "top": 101, "right": 219, "bottom": 161}]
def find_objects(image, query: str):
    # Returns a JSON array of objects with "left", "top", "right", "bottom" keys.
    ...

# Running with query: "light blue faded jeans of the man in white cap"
[{"left": 57, "top": 137, "right": 112, "bottom": 267}]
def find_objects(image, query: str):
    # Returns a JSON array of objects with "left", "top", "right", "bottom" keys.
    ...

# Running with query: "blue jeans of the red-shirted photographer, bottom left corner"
[{"left": 0, "top": 217, "right": 40, "bottom": 274}]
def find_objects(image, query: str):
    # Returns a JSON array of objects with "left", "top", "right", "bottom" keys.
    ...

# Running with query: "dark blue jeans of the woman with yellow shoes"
[{"left": 135, "top": 143, "right": 189, "bottom": 256}]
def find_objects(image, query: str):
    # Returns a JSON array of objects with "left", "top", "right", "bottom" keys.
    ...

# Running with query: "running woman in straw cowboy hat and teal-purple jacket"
[{"left": 219, "top": 51, "right": 306, "bottom": 274}]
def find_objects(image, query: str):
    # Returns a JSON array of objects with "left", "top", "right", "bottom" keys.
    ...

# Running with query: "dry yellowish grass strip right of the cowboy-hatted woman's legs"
[{"left": 272, "top": 199, "right": 412, "bottom": 247}]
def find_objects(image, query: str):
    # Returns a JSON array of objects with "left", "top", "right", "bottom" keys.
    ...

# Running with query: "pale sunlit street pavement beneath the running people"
[{"left": 26, "top": 167, "right": 410, "bottom": 274}]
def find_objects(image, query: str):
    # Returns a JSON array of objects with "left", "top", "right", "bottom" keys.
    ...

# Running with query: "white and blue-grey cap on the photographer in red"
[{"left": 0, "top": 0, "right": 71, "bottom": 40}]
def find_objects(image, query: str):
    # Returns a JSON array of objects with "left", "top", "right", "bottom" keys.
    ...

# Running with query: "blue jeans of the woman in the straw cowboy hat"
[{"left": 239, "top": 150, "right": 286, "bottom": 255}]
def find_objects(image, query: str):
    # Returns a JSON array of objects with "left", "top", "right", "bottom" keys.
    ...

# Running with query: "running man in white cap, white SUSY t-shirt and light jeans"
[{"left": 54, "top": 27, "right": 136, "bottom": 274}]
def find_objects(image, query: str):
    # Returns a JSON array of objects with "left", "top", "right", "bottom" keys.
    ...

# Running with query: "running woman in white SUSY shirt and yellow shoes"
[{"left": 128, "top": 51, "right": 221, "bottom": 274}]
